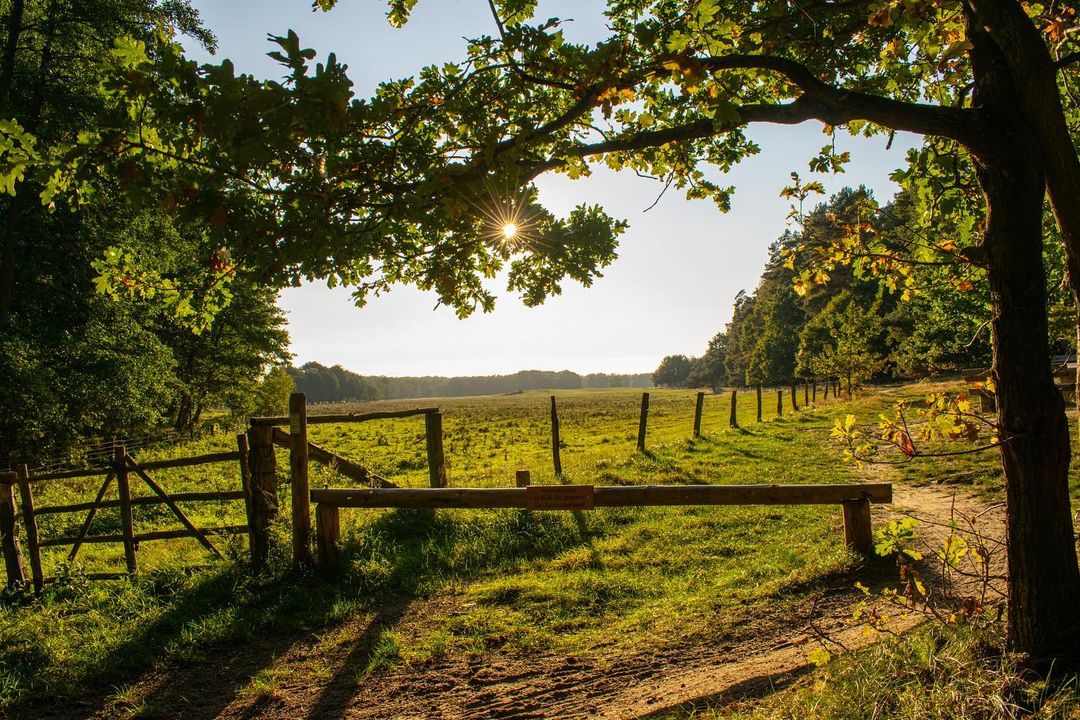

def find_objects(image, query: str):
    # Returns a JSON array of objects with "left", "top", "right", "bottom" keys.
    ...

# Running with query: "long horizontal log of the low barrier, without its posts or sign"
[{"left": 311, "top": 483, "right": 892, "bottom": 508}]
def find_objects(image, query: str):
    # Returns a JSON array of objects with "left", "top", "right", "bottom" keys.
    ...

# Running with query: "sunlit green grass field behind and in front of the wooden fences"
[{"left": 0, "top": 388, "right": 1045, "bottom": 706}]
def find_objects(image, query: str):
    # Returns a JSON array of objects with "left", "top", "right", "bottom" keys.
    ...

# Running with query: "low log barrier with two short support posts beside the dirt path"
[{"left": 311, "top": 481, "right": 892, "bottom": 562}]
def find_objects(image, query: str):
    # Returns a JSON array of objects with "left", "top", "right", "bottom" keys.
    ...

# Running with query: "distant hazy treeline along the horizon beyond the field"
[{"left": 288, "top": 363, "right": 652, "bottom": 403}]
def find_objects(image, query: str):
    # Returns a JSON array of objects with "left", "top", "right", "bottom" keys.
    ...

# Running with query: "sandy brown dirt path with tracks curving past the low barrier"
[{"left": 23, "top": 479, "right": 1004, "bottom": 720}]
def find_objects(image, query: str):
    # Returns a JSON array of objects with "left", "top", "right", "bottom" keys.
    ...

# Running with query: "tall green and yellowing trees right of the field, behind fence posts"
[{"left": 652, "top": 183, "right": 1074, "bottom": 390}]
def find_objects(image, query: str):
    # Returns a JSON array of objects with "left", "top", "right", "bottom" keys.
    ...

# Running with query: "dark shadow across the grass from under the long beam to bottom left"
[{"left": 10, "top": 511, "right": 590, "bottom": 718}]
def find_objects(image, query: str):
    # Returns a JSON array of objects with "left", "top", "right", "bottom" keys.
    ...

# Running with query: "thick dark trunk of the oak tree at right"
[{"left": 976, "top": 143, "right": 1080, "bottom": 658}]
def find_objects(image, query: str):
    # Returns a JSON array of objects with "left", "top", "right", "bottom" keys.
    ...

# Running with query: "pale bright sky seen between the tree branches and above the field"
[{"left": 185, "top": 0, "right": 917, "bottom": 376}]
